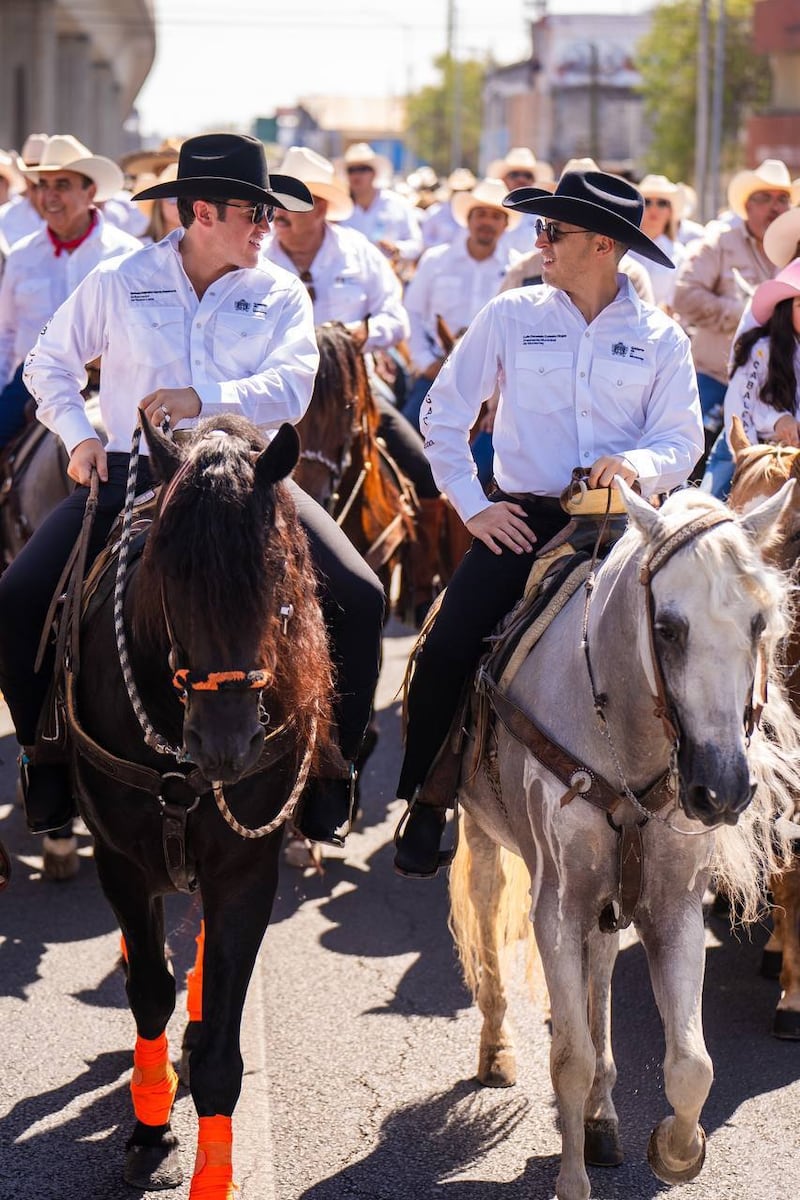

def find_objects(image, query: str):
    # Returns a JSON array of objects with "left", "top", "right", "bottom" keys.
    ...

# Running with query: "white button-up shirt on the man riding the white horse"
[{"left": 420, "top": 275, "right": 703, "bottom": 521}]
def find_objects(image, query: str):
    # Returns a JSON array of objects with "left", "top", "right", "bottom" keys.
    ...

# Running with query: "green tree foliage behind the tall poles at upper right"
[{"left": 637, "top": 0, "right": 771, "bottom": 180}]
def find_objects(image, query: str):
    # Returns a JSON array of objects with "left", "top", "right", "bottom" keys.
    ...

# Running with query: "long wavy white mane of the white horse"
[{"left": 609, "top": 487, "right": 800, "bottom": 923}]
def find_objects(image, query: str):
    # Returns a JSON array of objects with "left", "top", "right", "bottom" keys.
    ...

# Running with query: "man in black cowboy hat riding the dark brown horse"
[{"left": 0, "top": 133, "right": 384, "bottom": 845}]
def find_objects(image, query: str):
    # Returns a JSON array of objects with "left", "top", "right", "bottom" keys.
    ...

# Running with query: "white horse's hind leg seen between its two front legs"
[{"left": 584, "top": 928, "right": 622, "bottom": 1166}]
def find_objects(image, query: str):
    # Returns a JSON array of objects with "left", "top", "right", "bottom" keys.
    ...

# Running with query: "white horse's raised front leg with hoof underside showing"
[{"left": 639, "top": 890, "right": 714, "bottom": 1183}]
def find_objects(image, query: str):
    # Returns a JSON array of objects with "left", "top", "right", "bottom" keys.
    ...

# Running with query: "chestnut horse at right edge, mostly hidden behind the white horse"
[{"left": 728, "top": 416, "right": 800, "bottom": 1040}]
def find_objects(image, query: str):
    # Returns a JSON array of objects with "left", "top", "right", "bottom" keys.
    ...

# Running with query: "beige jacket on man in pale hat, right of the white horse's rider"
[{"left": 673, "top": 221, "right": 776, "bottom": 383}]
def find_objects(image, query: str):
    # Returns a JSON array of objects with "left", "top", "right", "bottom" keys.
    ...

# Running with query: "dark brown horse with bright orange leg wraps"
[{"left": 67, "top": 416, "right": 335, "bottom": 1200}]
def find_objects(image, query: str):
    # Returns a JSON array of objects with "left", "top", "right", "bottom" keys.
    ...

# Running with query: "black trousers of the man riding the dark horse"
[{"left": 0, "top": 454, "right": 384, "bottom": 758}]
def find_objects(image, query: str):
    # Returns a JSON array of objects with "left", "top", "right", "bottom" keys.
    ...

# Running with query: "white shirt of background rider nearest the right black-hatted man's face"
[{"left": 405, "top": 229, "right": 516, "bottom": 372}]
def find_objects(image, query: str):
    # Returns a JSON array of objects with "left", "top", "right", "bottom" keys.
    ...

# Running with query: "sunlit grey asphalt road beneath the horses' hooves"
[{"left": 0, "top": 626, "right": 800, "bottom": 1200}]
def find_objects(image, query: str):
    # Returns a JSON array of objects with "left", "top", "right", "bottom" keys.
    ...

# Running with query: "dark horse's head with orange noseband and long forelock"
[{"left": 133, "top": 416, "right": 326, "bottom": 782}]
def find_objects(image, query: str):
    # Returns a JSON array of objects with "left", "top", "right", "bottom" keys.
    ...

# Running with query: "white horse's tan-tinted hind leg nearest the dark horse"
[{"left": 451, "top": 812, "right": 517, "bottom": 1087}]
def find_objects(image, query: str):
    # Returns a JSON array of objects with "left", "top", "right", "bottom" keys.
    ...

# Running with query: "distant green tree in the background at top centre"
[{"left": 407, "top": 54, "right": 486, "bottom": 175}]
